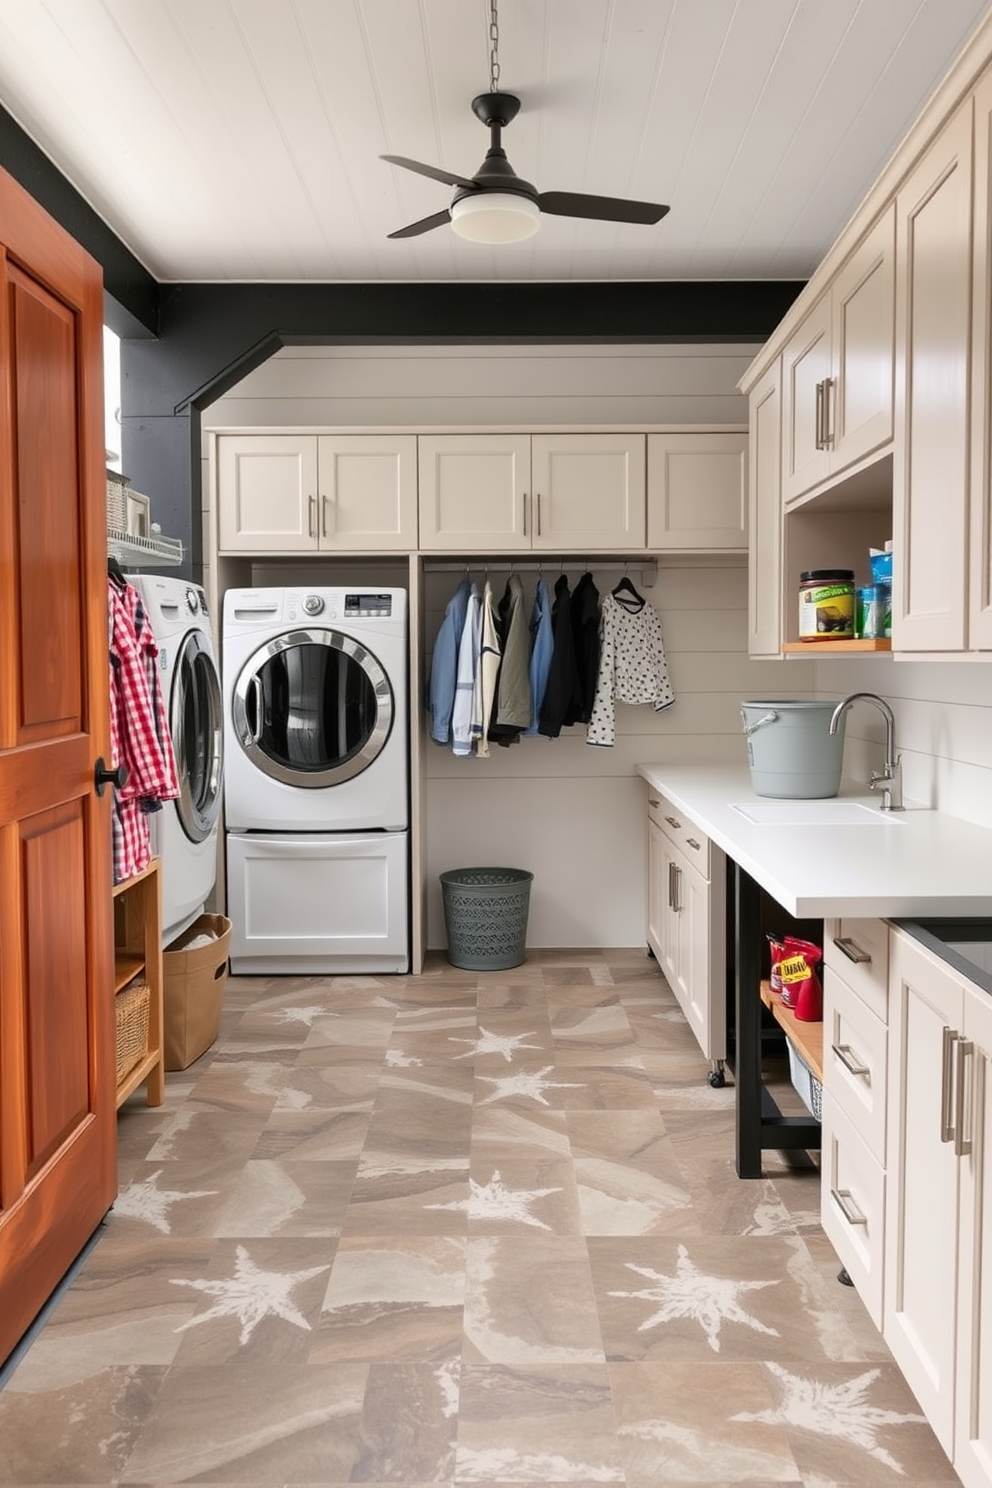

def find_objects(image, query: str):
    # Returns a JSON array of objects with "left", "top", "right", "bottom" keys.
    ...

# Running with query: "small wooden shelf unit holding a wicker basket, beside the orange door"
[{"left": 113, "top": 857, "right": 165, "bottom": 1109}]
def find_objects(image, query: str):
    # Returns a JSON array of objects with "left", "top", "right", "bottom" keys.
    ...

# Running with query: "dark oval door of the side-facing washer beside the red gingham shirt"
[{"left": 170, "top": 631, "right": 223, "bottom": 842}]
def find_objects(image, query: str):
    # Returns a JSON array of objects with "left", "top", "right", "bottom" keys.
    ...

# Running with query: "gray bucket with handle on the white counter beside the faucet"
[{"left": 741, "top": 698, "right": 846, "bottom": 801}]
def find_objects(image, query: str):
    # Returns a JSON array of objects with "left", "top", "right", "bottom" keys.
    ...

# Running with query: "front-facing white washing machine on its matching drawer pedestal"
[{"left": 222, "top": 588, "right": 409, "bottom": 975}]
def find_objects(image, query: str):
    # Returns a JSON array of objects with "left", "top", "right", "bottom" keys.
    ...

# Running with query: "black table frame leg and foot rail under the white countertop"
[{"left": 733, "top": 863, "right": 819, "bottom": 1178}]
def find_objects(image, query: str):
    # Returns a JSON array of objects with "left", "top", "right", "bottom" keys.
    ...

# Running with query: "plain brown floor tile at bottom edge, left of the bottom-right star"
[{"left": 610, "top": 1360, "right": 802, "bottom": 1488}]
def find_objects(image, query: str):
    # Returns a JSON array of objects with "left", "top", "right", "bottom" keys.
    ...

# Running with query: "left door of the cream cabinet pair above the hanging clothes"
[{"left": 418, "top": 434, "right": 531, "bottom": 554}]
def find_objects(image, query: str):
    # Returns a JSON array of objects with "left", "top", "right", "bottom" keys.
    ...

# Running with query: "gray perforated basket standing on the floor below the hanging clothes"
[{"left": 440, "top": 868, "right": 534, "bottom": 972}]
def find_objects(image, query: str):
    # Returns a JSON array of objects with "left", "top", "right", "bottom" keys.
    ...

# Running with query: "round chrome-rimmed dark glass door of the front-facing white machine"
[{"left": 232, "top": 629, "right": 393, "bottom": 790}]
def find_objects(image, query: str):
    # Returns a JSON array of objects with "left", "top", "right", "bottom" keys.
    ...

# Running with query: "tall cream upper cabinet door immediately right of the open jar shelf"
[{"left": 892, "top": 103, "right": 971, "bottom": 650}]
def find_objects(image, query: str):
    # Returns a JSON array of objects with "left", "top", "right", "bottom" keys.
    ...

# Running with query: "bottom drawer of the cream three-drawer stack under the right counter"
[{"left": 819, "top": 1086, "right": 885, "bottom": 1329}]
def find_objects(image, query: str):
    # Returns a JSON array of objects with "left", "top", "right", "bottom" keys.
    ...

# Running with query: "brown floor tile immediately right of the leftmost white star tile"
[{"left": 214, "top": 1159, "right": 357, "bottom": 1238}]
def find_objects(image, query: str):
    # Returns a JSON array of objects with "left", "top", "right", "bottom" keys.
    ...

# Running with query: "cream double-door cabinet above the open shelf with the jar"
[{"left": 782, "top": 207, "right": 895, "bottom": 503}]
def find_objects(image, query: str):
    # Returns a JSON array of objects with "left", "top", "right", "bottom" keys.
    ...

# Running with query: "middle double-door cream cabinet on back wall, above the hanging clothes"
[{"left": 419, "top": 433, "right": 645, "bottom": 554}]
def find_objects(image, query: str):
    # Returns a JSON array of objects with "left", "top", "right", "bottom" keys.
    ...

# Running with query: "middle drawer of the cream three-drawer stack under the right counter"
[{"left": 824, "top": 967, "right": 888, "bottom": 1164}]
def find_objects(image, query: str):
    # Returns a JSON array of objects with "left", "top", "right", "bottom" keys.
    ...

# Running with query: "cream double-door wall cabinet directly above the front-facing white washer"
[{"left": 217, "top": 433, "right": 416, "bottom": 554}]
